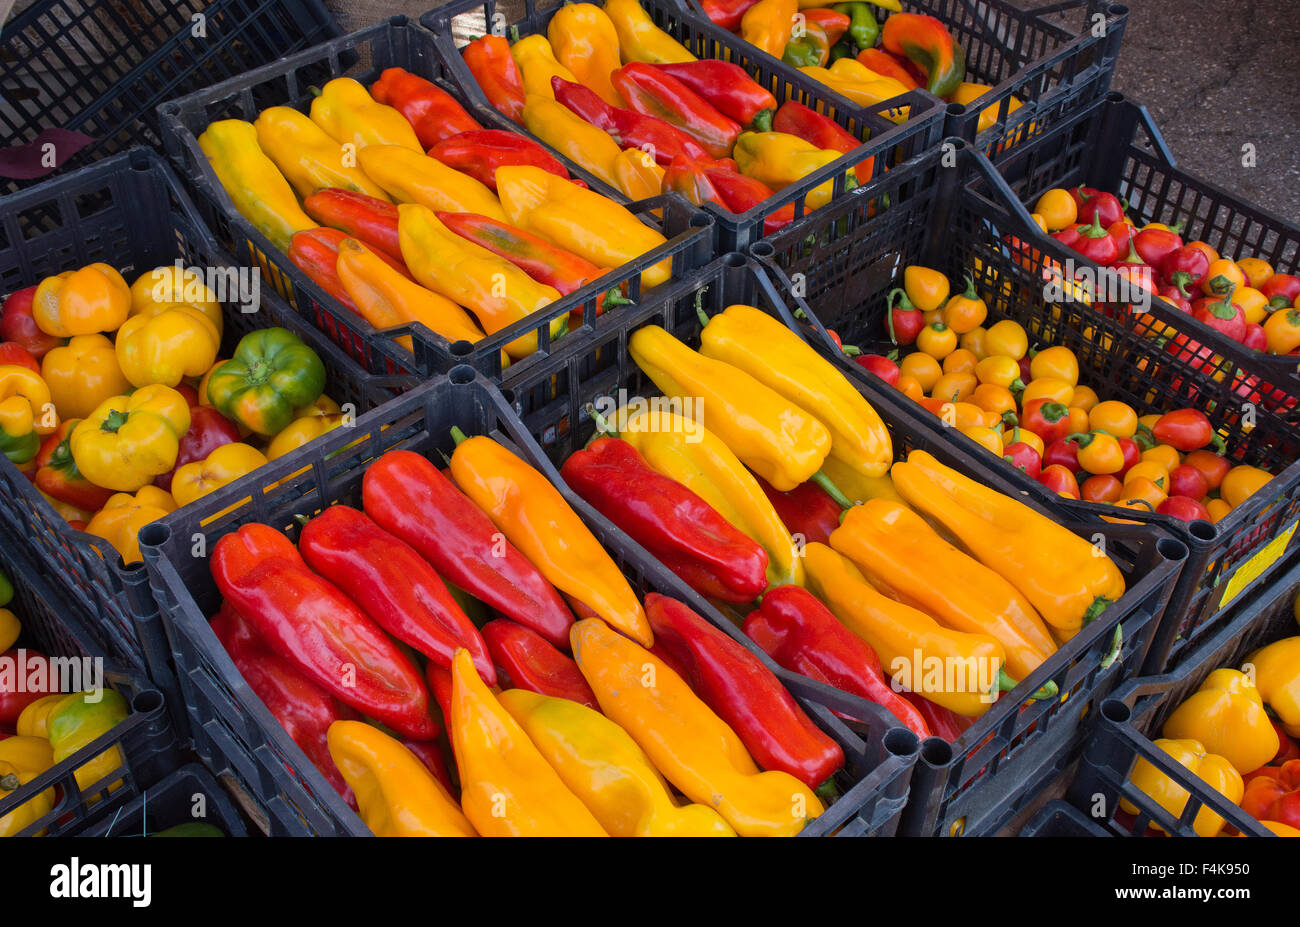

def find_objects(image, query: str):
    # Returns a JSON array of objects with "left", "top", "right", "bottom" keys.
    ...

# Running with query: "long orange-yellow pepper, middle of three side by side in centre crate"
[{"left": 831, "top": 499, "right": 1057, "bottom": 679}]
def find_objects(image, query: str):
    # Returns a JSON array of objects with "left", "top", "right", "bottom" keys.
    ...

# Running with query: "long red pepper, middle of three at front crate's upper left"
[{"left": 298, "top": 504, "right": 497, "bottom": 685}]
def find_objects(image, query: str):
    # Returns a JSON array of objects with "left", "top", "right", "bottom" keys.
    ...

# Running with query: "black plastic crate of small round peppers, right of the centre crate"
[{"left": 754, "top": 135, "right": 1300, "bottom": 673}]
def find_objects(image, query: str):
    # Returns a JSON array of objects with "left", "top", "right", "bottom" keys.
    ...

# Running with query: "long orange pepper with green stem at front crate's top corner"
[{"left": 451, "top": 434, "right": 654, "bottom": 646}]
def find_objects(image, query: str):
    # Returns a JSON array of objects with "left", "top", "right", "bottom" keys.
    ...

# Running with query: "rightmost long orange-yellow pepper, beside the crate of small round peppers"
[{"left": 892, "top": 451, "right": 1125, "bottom": 631}]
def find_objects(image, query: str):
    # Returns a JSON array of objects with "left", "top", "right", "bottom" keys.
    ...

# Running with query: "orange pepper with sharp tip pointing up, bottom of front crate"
[{"left": 447, "top": 650, "right": 608, "bottom": 837}]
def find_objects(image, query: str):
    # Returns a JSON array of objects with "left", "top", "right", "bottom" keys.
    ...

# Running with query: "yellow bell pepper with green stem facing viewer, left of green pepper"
[{"left": 69, "top": 384, "right": 190, "bottom": 493}]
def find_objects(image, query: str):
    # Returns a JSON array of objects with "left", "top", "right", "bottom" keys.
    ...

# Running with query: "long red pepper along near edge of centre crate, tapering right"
[{"left": 738, "top": 586, "right": 931, "bottom": 738}]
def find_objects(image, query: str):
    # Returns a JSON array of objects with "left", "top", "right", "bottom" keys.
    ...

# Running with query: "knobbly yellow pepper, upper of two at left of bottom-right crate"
[{"left": 1161, "top": 670, "right": 1281, "bottom": 774}]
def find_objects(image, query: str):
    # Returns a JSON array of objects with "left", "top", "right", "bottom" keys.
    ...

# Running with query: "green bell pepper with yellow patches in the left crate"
[{"left": 208, "top": 329, "right": 325, "bottom": 436}]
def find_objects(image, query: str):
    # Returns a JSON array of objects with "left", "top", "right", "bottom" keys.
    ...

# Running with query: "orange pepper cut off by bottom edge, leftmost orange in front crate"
[{"left": 325, "top": 720, "right": 478, "bottom": 837}]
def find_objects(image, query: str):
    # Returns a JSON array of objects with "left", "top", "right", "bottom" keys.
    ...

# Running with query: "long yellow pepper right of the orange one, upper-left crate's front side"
[{"left": 398, "top": 203, "right": 566, "bottom": 359}]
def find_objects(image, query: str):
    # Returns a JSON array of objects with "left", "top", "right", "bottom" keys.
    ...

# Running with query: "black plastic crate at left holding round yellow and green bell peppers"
[{"left": 0, "top": 148, "right": 413, "bottom": 696}]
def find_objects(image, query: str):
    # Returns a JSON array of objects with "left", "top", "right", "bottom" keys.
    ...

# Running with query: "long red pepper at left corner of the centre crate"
[{"left": 560, "top": 438, "right": 767, "bottom": 602}]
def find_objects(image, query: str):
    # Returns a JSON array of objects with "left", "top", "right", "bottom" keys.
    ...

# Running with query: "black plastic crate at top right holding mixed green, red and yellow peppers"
[{"left": 683, "top": 0, "right": 1128, "bottom": 153}]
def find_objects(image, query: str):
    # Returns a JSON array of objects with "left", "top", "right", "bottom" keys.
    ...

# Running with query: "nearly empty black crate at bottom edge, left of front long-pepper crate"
[{"left": 77, "top": 763, "right": 248, "bottom": 837}]
